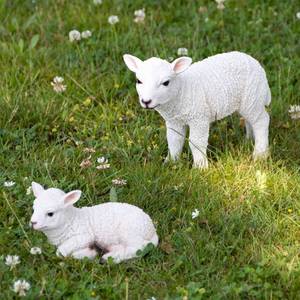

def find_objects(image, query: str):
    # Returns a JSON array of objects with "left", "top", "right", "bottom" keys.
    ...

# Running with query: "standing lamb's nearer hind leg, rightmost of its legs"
[{"left": 251, "top": 109, "right": 270, "bottom": 159}]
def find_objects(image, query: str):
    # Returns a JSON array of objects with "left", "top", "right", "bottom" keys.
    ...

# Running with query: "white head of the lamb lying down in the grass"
[{"left": 30, "top": 182, "right": 81, "bottom": 231}]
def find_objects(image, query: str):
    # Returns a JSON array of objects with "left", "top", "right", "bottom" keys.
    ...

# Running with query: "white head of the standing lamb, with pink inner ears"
[{"left": 123, "top": 54, "right": 192, "bottom": 108}]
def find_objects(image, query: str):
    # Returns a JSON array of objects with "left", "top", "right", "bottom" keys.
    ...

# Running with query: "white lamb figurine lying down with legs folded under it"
[{"left": 31, "top": 182, "right": 158, "bottom": 263}]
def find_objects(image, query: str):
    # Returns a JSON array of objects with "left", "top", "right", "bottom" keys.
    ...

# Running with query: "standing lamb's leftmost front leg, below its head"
[{"left": 166, "top": 122, "right": 186, "bottom": 161}]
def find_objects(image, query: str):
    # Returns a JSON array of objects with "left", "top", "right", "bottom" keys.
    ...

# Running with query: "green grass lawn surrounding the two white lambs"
[{"left": 0, "top": 0, "right": 300, "bottom": 299}]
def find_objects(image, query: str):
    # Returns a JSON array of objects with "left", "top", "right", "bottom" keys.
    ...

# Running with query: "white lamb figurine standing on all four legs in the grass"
[{"left": 123, "top": 52, "right": 271, "bottom": 168}]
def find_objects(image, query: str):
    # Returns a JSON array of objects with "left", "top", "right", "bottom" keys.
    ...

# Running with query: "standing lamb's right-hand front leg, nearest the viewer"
[{"left": 189, "top": 120, "right": 209, "bottom": 169}]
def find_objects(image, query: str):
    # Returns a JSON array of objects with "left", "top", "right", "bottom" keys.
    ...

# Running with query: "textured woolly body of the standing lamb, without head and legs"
[{"left": 156, "top": 52, "right": 271, "bottom": 124}]
